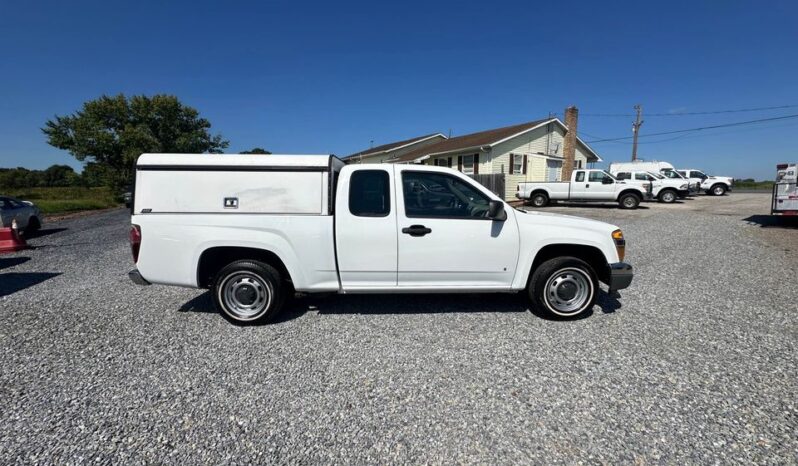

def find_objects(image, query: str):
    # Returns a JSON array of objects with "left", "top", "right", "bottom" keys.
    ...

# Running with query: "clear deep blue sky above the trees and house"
[{"left": 0, "top": 0, "right": 798, "bottom": 179}]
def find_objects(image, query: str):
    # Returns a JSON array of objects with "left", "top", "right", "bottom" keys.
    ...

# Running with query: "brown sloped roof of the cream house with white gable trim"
[{"left": 390, "top": 118, "right": 601, "bottom": 163}]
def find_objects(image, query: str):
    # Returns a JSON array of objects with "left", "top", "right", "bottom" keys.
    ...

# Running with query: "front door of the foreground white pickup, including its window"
[{"left": 396, "top": 166, "right": 519, "bottom": 290}]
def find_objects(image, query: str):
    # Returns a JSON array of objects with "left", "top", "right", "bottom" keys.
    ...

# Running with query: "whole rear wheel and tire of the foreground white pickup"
[{"left": 213, "top": 260, "right": 285, "bottom": 324}]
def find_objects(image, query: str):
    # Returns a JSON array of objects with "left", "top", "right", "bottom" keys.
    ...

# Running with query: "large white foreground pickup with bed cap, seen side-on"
[{"left": 129, "top": 154, "right": 632, "bottom": 323}]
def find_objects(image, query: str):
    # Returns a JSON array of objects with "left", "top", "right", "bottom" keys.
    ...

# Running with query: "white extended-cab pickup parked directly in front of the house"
[{"left": 515, "top": 169, "right": 652, "bottom": 209}]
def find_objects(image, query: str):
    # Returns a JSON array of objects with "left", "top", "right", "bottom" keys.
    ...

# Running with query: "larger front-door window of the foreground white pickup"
[{"left": 402, "top": 170, "right": 490, "bottom": 218}]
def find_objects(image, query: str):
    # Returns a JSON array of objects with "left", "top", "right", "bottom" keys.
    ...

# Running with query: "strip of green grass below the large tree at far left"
[{"left": 0, "top": 187, "right": 121, "bottom": 215}]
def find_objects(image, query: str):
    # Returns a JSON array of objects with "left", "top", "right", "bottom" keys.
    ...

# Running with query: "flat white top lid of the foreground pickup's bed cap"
[{"left": 137, "top": 154, "right": 333, "bottom": 170}]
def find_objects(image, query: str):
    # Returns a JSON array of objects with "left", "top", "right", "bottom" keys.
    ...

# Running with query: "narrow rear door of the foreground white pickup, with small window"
[{"left": 335, "top": 165, "right": 397, "bottom": 290}]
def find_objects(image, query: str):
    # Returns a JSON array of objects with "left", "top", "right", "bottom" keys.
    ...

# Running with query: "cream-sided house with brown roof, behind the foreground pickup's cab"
[{"left": 346, "top": 116, "right": 601, "bottom": 200}]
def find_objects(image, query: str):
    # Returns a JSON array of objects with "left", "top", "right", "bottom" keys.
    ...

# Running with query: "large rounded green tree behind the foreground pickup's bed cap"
[{"left": 42, "top": 94, "right": 229, "bottom": 189}]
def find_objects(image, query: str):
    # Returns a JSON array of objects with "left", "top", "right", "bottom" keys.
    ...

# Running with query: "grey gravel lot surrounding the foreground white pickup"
[{"left": 0, "top": 193, "right": 798, "bottom": 464}]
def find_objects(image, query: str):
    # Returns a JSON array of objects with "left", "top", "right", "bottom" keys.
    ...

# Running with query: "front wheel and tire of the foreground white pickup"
[{"left": 527, "top": 256, "right": 599, "bottom": 318}]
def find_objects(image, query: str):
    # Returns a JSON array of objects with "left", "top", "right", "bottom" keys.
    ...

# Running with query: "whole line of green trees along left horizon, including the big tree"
[{"left": 0, "top": 94, "right": 270, "bottom": 192}]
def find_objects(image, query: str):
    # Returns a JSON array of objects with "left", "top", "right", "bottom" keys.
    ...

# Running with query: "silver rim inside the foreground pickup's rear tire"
[{"left": 219, "top": 272, "right": 273, "bottom": 320}]
